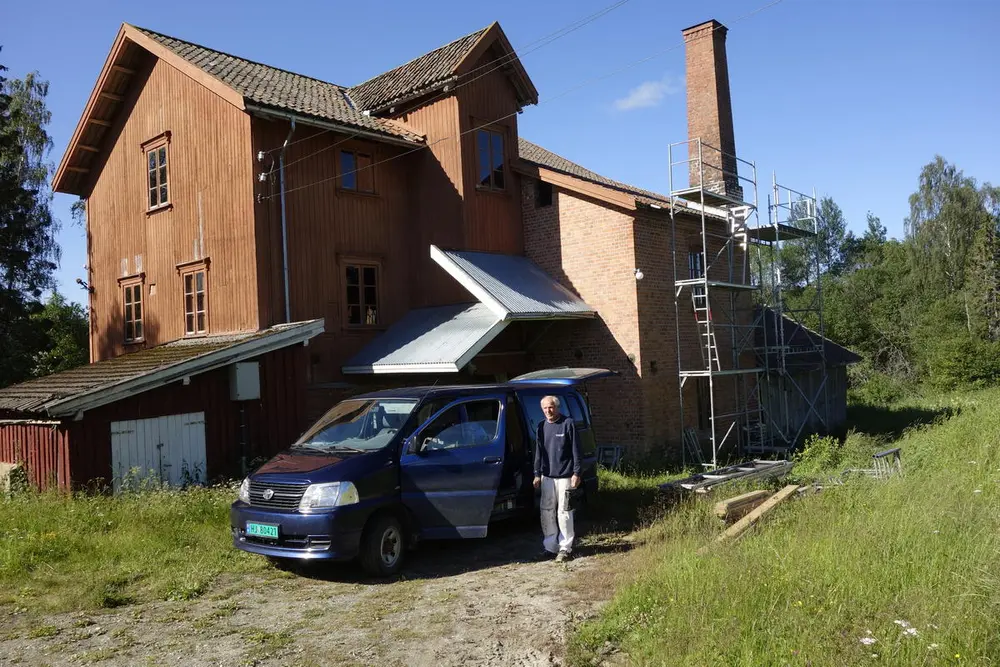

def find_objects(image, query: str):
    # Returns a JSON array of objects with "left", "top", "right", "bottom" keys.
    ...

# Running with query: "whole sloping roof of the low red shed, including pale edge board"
[{"left": 0, "top": 320, "right": 323, "bottom": 417}]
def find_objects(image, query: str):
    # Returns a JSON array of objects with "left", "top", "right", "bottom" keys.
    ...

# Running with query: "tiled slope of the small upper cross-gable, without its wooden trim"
[{"left": 348, "top": 27, "right": 489, "bottom": 110}]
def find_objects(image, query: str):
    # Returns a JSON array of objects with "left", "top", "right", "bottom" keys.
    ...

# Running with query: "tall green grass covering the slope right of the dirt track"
[{"left": 569, "top": 390, "right": 1000, "bottom": 667}]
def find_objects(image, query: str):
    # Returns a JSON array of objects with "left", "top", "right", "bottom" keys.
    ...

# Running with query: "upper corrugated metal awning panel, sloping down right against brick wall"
[{"left": 431, "top": 245, "right": 596, "bottom": 320}]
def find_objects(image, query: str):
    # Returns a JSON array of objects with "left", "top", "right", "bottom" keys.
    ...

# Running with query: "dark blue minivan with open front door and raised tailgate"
[{"left": 229, "top": 368, "right": 615, "bottom": 576}]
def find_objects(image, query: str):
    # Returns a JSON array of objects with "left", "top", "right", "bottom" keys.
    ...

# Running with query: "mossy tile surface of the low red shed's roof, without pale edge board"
[{"left": 0, "top": 322, "right": 321, "bottom": 413}]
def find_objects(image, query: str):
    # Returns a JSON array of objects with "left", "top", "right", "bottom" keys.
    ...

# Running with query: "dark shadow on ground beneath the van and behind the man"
[{"left": 288, "top": 480, "right": 666, "bottom": 584}]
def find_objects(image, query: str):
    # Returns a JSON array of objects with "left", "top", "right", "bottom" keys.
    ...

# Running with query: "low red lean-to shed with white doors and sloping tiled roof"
[{"left": 0, "top": 320, "right": 323, "bottom": 490}]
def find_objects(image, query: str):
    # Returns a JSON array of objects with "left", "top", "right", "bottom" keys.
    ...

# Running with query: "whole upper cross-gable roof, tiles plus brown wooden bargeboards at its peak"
[{"left": 348, "top": 22, "right": 538, "bottom": 113}]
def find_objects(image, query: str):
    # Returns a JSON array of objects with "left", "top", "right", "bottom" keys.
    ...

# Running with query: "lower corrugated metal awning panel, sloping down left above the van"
[{"left": 343, "top": 303, "right": 507, "bottom": 374}]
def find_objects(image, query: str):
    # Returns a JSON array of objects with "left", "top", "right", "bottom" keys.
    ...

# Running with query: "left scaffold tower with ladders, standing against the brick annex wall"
[{"left": 668, "top": 139, "right": 763, "bottom": 469}]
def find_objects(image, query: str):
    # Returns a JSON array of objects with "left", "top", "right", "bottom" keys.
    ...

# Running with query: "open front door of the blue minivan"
[{"left": 400, "top": 394, "right": 505, "bottom": 539}]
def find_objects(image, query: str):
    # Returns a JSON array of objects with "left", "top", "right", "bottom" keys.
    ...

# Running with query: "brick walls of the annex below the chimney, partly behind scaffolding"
[{"left": 522, "top": 182, "right": 752, "bottom": 459}]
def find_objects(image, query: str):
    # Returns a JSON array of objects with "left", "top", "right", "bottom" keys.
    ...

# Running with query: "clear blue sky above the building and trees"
[{"left": 0, "top": 0, "right": 1000, "bottom": 301}]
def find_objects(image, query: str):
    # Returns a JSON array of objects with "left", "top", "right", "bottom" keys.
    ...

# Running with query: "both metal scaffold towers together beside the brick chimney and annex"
[{"left": 668, "top": 144, "right": 829, "bottom": 469}]
